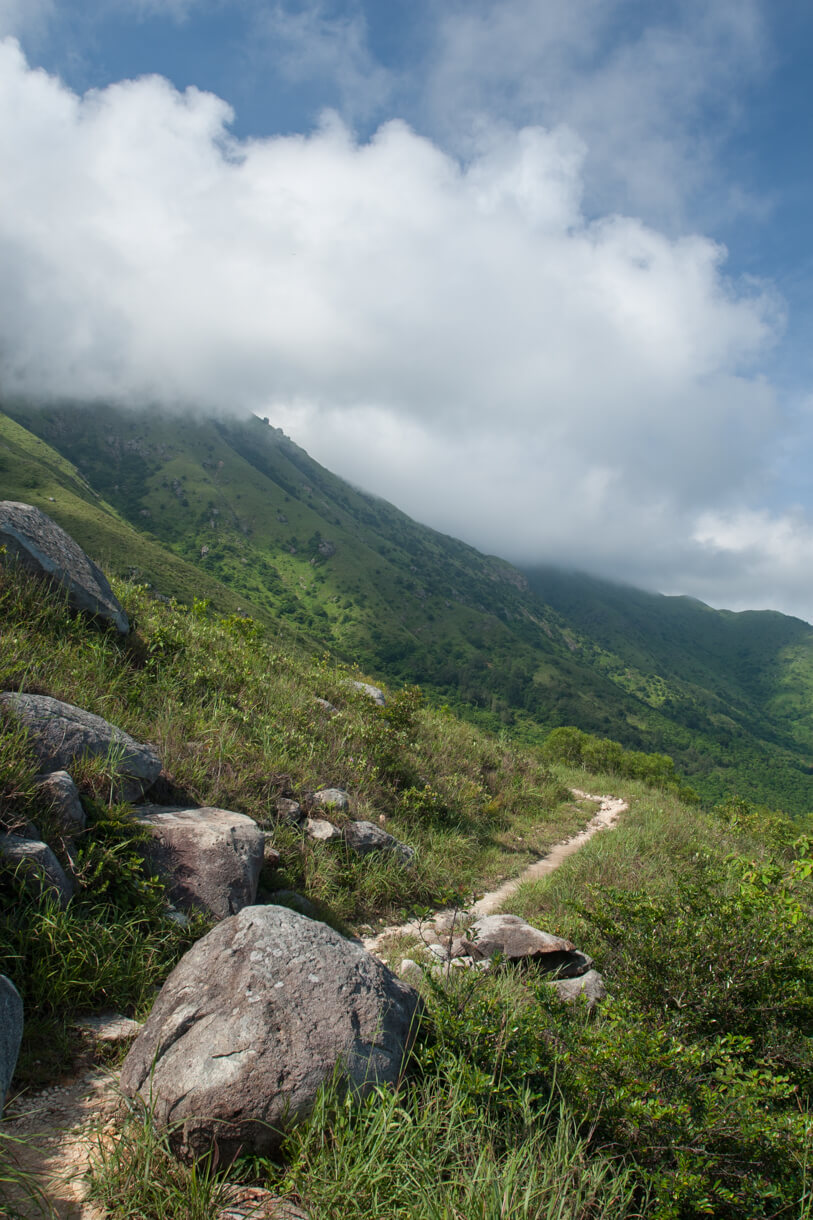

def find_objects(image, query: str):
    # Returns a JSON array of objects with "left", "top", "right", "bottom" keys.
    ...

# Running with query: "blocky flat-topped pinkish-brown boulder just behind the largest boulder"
[{"left": 138, "top": 805, "right": 265, "bottom": 919}]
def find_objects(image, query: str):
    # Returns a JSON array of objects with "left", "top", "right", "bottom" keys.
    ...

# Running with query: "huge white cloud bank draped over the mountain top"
[{"left": 0, "top": 0, "right": 813, "bottom": 617}]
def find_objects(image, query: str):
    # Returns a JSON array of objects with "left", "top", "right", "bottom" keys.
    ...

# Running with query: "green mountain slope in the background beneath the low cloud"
[{"left": 0, "top": 400, "right": 813, "bottom": 811}]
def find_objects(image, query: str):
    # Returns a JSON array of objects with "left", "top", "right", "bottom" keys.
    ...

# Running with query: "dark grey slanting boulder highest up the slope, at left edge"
[{"left": 0, "top": 500, "right": 129, "bottom": 636}]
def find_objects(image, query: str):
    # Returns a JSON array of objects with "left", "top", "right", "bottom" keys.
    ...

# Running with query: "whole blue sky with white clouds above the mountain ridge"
[{"left": 0, "top": 0, "right": 813, "bottom": 621}]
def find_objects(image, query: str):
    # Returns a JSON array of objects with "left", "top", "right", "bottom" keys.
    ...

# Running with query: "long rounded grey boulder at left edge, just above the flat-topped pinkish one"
[{"left": 0, "top": 691, "right": 161, "bottom": 800}]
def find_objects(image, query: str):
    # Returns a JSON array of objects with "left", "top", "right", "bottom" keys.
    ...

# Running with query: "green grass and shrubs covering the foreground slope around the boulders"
[{"left": 0, "top": 556, "right": 813, "bottom": 1220}]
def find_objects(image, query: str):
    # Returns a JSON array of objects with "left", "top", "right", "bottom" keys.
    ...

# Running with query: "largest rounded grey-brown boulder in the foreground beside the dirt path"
[{"left": 121, "top": 906, "right": 419, "bottom": 1159}]
